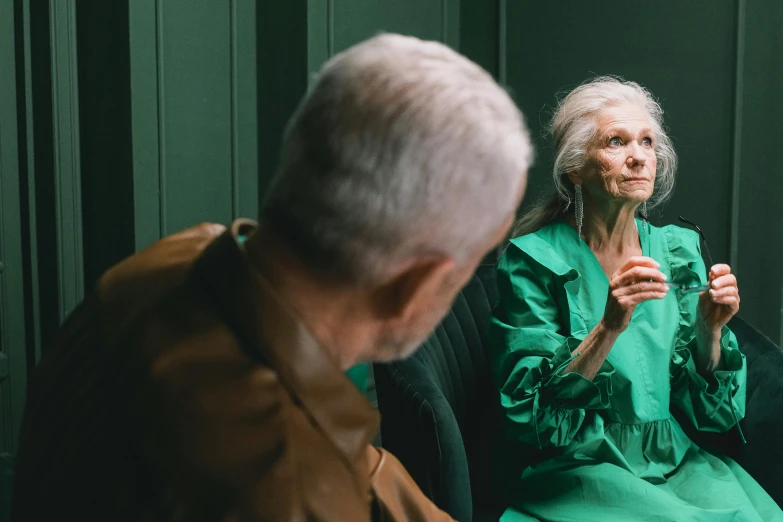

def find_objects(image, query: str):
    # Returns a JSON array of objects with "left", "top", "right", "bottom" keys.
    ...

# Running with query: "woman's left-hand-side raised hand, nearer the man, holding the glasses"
[{"left": 602, "top": 256, "right": 669, "bottom": 333}]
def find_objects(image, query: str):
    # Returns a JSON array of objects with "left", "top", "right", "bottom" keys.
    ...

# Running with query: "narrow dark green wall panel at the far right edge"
[{"left": 736, "top": 0, "right": 783, "bottom": 346}]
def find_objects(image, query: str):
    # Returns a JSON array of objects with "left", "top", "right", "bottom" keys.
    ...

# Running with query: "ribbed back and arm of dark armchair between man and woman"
[{"left": 374, "top": 265, "right": 502, "bottom": 521}]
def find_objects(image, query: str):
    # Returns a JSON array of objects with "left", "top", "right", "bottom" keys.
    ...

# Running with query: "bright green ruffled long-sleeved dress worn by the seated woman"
[{"left": 489, "top": 221, "right": 783, "bottom": 522}]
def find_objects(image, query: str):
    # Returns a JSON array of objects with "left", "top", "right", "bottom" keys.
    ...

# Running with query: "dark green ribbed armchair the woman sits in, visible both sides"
[{"left": 374, "top": 265, "right": 783, "bottom": 522}]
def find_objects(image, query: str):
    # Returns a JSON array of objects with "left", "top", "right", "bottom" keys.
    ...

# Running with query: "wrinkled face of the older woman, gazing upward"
[{"left": 572, "top": 105, "right": 656, "bottom": 203}]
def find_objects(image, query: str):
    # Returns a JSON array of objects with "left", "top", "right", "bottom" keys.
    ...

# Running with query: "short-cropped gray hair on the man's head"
[{"left": 262, "top": 34, "right": 532, "bottom": 283}]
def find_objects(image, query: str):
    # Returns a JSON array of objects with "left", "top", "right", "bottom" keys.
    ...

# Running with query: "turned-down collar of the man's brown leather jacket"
[{"left": 192, "top": 220, "right": 379, "bottom": 476}]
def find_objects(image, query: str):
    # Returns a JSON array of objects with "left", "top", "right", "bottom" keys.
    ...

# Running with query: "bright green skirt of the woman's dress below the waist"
[{"left": 501, "top": 420, "right": 783, "bottom": 522}]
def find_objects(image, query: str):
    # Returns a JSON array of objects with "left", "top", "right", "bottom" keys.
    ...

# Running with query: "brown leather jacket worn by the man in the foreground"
[{"left": 12, "top": 221, "right": 451, "bottom": 522}]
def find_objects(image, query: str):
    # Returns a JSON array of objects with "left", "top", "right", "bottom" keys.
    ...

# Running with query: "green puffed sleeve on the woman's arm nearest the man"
[{"left": 490, "top": 238, "right": 614, "bottom": 447}]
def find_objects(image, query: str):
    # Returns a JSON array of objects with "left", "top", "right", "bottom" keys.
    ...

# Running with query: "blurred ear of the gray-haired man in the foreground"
[{"left": 373, "top": 256, "right": 456, "bottom": 322}]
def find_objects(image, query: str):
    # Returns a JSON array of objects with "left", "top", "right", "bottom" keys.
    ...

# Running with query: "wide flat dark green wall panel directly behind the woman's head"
[{"left": 505, "top": 0, "right": 735, "bottom": 253}]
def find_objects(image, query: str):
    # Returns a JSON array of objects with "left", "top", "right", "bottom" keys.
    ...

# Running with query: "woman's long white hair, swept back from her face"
[{"left": 512, "top": 76, "right": 677, "bottom": 237}]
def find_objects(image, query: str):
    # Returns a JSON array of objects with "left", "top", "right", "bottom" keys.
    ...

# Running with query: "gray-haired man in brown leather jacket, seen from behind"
[{"left": 13, "top": 35, "right": 532, "bottom": 522}]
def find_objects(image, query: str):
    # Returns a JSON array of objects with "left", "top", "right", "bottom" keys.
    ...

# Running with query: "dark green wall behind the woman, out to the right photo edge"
[{"left": 499, "top": 0, "right": 783, "bottom": 341}]
